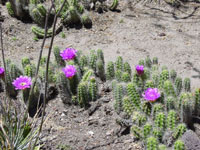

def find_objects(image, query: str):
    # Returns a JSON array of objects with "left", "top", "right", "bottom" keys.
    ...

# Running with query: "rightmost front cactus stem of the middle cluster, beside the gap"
[{"left": 96, "top": 59, "right": 106, "bottom": 81}]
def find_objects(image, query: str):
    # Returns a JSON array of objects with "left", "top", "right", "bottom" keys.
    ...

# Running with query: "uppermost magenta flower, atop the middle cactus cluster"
[{"left": 60, "top": 48, "right": 77, "bottom": 60}]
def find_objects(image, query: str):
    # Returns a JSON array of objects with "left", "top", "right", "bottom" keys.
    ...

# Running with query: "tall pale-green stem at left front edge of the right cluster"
[{"left": 114, "top": 84, "right": 124, "bottom": 113}]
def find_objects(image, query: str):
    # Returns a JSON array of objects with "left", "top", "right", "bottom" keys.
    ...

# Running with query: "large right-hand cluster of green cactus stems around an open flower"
[{"left": 110, "top": 57, "right": 200, "bottom": 150}]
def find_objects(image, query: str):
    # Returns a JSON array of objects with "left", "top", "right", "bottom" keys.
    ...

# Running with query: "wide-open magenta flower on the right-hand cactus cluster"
[{"left": 142, "top": 88, "right": 160, "bottom": 102}]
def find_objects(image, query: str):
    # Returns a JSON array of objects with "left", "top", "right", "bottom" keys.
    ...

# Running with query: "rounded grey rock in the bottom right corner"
[{"left": 181, "top": 130, "right": 200, "bottom": 150}]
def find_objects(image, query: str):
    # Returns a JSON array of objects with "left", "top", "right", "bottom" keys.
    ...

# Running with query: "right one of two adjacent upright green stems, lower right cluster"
[{"left": 167, "top": 110, "right": 177, "bottom": 130}]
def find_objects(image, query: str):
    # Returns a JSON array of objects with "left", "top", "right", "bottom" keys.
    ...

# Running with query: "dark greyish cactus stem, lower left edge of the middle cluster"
[{"left": 56, "top": 72, "right": 72, "bottom": 104}]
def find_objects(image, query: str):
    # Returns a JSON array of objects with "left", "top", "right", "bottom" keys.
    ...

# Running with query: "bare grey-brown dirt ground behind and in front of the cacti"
[{"left": 0, "top": 0, "right": 200, "bottom": 150}]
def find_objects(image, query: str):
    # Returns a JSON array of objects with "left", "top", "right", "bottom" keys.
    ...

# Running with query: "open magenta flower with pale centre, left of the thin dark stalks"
[{"left": 12, "top": 76, "right": 32, "bottom": 90}]
